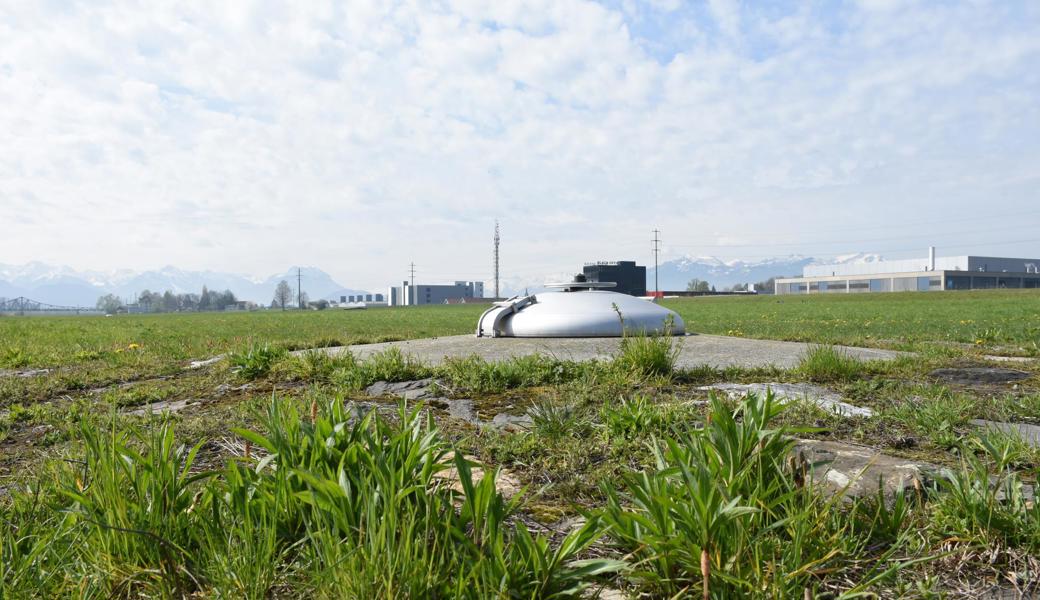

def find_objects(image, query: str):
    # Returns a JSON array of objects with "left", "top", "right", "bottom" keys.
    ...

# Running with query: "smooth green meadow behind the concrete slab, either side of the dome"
[{"left": 0, "top": 290, "right": 1040, "bottom": 368}]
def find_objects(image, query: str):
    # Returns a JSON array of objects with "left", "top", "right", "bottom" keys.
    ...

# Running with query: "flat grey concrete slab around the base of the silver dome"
[{"left": 327, "top": 334, "right": 900, "bottom": 369}]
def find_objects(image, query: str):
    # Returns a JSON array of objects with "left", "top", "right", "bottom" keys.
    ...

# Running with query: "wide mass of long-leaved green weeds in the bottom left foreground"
[{"left": 0, "top": 399, "right": 624, "bottom": 598}]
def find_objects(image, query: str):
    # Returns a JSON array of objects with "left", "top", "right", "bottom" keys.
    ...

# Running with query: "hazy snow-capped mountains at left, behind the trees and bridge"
[{"left": 0, "top": 262, "right": 366, "bottom": 307}]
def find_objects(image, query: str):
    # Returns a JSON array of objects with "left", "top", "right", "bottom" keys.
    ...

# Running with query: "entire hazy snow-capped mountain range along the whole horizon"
[{"left": 0, "top": 254, "right": 881, "bottom": 307}]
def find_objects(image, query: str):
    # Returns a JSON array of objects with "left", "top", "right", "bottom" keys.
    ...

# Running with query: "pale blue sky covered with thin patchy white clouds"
[{"left": 0, "top": 0, "right": 1040, "bottom": 289}]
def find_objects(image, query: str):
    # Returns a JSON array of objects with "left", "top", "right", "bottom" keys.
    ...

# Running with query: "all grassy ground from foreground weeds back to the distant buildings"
[{"left": 0, "top": 291, "right": 1040, "bottom": 599}]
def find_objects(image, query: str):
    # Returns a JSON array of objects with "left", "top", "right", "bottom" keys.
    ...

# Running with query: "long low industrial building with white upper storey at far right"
[{"left": 776, "top": 247, "right": 1040, "bottom": 294}]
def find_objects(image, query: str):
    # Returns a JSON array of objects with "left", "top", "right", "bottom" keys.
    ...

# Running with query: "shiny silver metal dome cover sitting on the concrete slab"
[{"left": 476, "top": 286, "right": 685, "bottom": 338}]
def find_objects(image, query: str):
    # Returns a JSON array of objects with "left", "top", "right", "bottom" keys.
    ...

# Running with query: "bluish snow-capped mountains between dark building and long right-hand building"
[{"left": 647, "top": 253, "right": 881, "bottom": 290}]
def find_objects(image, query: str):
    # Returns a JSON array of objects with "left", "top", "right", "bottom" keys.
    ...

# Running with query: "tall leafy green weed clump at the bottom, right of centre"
[{"left": 597, "top": 394, "right": 919, "bottom": 598}]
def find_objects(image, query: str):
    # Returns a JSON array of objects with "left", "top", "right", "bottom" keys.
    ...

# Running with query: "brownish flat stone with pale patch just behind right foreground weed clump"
[{"left": 794, "top": 440, "right": 939, "bottom": 498}]
